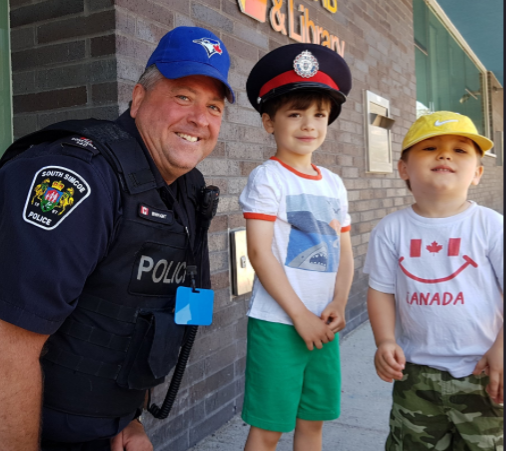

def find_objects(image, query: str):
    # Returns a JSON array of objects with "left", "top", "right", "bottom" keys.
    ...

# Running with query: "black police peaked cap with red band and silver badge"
[{"left": 246, "top": 44, "right": 351, "bottom": 124}]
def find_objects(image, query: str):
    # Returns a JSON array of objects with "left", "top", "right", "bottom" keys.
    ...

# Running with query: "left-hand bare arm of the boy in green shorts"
[{"left": 246, "top": 219, "right": 334, "bottom": 351}]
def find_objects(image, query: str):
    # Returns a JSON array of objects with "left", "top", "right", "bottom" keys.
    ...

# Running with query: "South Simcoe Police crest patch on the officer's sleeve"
[{"left": 23, "top": 166, "right": 91, "bottom": 230}]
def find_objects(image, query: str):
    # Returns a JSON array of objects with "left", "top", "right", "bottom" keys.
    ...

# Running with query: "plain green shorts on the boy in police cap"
[{"left": 242, "top": 318, "right": 341, "bottom": 432}]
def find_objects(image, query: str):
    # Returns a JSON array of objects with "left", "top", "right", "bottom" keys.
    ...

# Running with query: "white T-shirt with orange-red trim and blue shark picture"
[{"left": 239, "top": 157, "right": 351, "bottom": 324}]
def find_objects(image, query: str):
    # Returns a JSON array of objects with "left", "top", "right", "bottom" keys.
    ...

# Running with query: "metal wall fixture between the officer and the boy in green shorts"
[{"left": 230, "top": 227, "right": 255, "bottom": 296}]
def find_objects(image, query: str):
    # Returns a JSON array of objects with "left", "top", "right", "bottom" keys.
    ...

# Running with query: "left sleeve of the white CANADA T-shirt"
[{"left": 363, "top": 222, "right": 397, "bottom": 294}]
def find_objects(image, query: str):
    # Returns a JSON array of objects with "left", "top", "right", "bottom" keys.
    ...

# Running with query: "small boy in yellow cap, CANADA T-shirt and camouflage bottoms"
[{"left": 364, "top": 111, "right": 503, "bottom": 451}]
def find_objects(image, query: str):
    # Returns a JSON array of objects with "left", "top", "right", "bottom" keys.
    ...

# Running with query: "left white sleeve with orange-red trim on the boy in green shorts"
[{"left": 239, "top": 166, "right": 281, "bottom": 221}]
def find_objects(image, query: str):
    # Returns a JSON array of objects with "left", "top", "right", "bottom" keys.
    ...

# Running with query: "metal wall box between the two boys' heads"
[{"left": 364, "top": 91, "right": 395, "bottom": 174}]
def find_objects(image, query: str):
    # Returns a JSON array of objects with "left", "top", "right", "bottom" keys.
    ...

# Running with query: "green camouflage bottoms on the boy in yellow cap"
[{"left": 385, "top": 363, "right": 503, "bottom": 451}]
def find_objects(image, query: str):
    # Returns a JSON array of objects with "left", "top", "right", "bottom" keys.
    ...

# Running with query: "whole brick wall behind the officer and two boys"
[{"left": 10, "top": 0, "right": 502, "bottom": 451}]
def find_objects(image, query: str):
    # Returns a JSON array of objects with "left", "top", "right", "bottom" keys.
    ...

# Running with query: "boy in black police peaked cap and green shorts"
[{"left": 239, "top": 44, "right": 353, "bottom": 451}]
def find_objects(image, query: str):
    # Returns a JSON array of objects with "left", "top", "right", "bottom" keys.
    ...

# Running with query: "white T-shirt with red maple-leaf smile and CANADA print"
[{"left": 364, "top": 202, "right": 503, "bottom": 377}]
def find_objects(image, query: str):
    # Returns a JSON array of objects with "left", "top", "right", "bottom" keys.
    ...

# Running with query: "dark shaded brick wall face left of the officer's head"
[{"left": 10, "top": 0, "right": 118, "bottom": 138}]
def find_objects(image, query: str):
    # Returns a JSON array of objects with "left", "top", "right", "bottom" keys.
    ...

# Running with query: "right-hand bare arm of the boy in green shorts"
[{"left": 321, "top": 232, "right": 354, "bottom": 333}]
